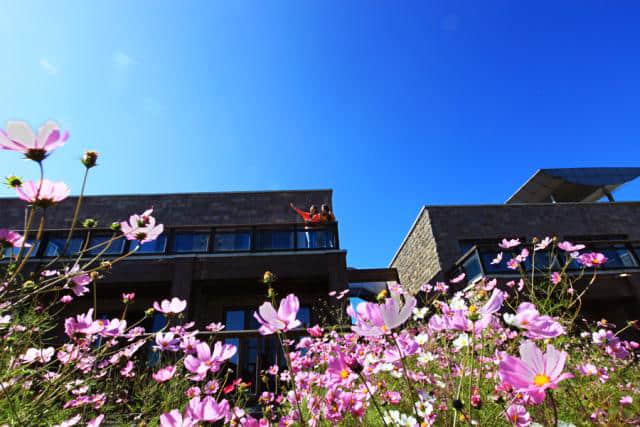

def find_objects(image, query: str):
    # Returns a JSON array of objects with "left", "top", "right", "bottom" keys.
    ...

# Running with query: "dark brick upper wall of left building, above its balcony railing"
[{"left": 0, "top": 190, "right": 333, "bottom": 229}]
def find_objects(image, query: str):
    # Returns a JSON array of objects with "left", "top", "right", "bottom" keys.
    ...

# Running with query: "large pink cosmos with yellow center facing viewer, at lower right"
[{"left": 500, "top": 341, "right": 573, "bottom": 404}]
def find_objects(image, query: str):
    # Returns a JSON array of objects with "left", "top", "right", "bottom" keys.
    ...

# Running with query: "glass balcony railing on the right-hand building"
[{"left": 447, "top": 240, "right": 640, "bottom": 283}]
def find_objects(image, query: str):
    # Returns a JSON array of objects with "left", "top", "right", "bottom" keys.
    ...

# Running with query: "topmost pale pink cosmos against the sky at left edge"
[{"left": 0, "top": 121, "right": 69, "bottom": 162}]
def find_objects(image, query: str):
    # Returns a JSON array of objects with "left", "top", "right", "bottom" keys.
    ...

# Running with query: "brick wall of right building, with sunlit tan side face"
[{"left": 391, "top": 202, "right": 640, "bottom": 289}]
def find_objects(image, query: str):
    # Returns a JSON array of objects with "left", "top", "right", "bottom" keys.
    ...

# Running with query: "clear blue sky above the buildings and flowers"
[{"left": 0, "top": 0, "right": 640, "bottom": 267}]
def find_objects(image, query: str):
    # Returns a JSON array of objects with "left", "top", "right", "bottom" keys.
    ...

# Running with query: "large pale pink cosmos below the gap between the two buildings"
[{"left": 347, "top": 295, "right": 417, "bottom": 336}]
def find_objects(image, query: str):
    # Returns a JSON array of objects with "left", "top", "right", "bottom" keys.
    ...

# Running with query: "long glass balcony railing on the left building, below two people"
[{"left": 5, "top": 223, "right": 340, "bottom": 258}]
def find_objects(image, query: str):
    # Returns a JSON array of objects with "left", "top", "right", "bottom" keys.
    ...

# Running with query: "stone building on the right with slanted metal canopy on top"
[{"left": 390, "top": 168, "right": 640, "bottom": 319}]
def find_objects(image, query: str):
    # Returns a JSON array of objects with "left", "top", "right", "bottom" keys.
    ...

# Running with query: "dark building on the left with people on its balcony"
[{"left": 0, "top": 190, "right": 397, "bottom": 390}]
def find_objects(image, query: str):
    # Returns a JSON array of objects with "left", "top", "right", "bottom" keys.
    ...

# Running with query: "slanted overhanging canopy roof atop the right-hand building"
[{"left": 505, "top": 167, "right": 640, "bottom": 204}]
